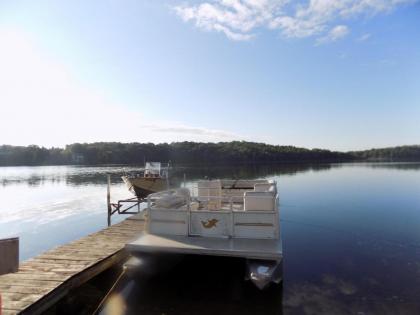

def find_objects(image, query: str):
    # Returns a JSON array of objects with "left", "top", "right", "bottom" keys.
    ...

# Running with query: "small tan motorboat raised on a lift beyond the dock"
[{"left": 122, "top": 162, "right": 169, "bottom": 199}]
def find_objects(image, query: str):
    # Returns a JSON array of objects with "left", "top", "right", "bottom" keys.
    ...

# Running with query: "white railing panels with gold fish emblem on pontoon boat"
[{"left": 146, "top": 188, "right": 279, "bottom": 238}]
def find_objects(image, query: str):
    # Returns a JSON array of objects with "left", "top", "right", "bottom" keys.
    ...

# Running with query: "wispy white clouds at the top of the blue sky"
[{"left": 175, "top": 0, "right": 416, "bottom": 41}]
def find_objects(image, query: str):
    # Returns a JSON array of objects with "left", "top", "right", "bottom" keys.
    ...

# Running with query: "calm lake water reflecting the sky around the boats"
[{"left": 0, "top": 163, "right": 420, "bottom": 315}]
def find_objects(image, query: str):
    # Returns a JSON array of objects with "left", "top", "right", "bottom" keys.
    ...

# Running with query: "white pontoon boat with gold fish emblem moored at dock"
[{"left": 126, "top": 180, "right": 283, "bottom": 289}]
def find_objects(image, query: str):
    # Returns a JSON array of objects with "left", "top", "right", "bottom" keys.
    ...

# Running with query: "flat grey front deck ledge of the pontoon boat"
[{"left": 126, "top": 232, "right": 283, "bottom": 260}]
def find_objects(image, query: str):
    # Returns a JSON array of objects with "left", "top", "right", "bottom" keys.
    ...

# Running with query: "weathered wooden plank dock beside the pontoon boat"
[{"left": 0, "top": 216, "right": 144, "bottom": 315}]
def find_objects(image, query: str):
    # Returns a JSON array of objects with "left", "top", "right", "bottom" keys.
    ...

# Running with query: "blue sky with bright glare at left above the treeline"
[{"left": 0, "top": 0, "right": 420, "bottom": 151}]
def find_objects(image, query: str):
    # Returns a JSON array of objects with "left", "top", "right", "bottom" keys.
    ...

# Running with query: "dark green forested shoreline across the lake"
[{"left": 0, "top": 141, "right": 420, "bottom": 166}]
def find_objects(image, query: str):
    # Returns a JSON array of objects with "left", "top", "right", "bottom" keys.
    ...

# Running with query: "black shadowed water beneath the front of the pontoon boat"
[{"left": 118, "top": 255, "right": 283, "bottom": 315}]
